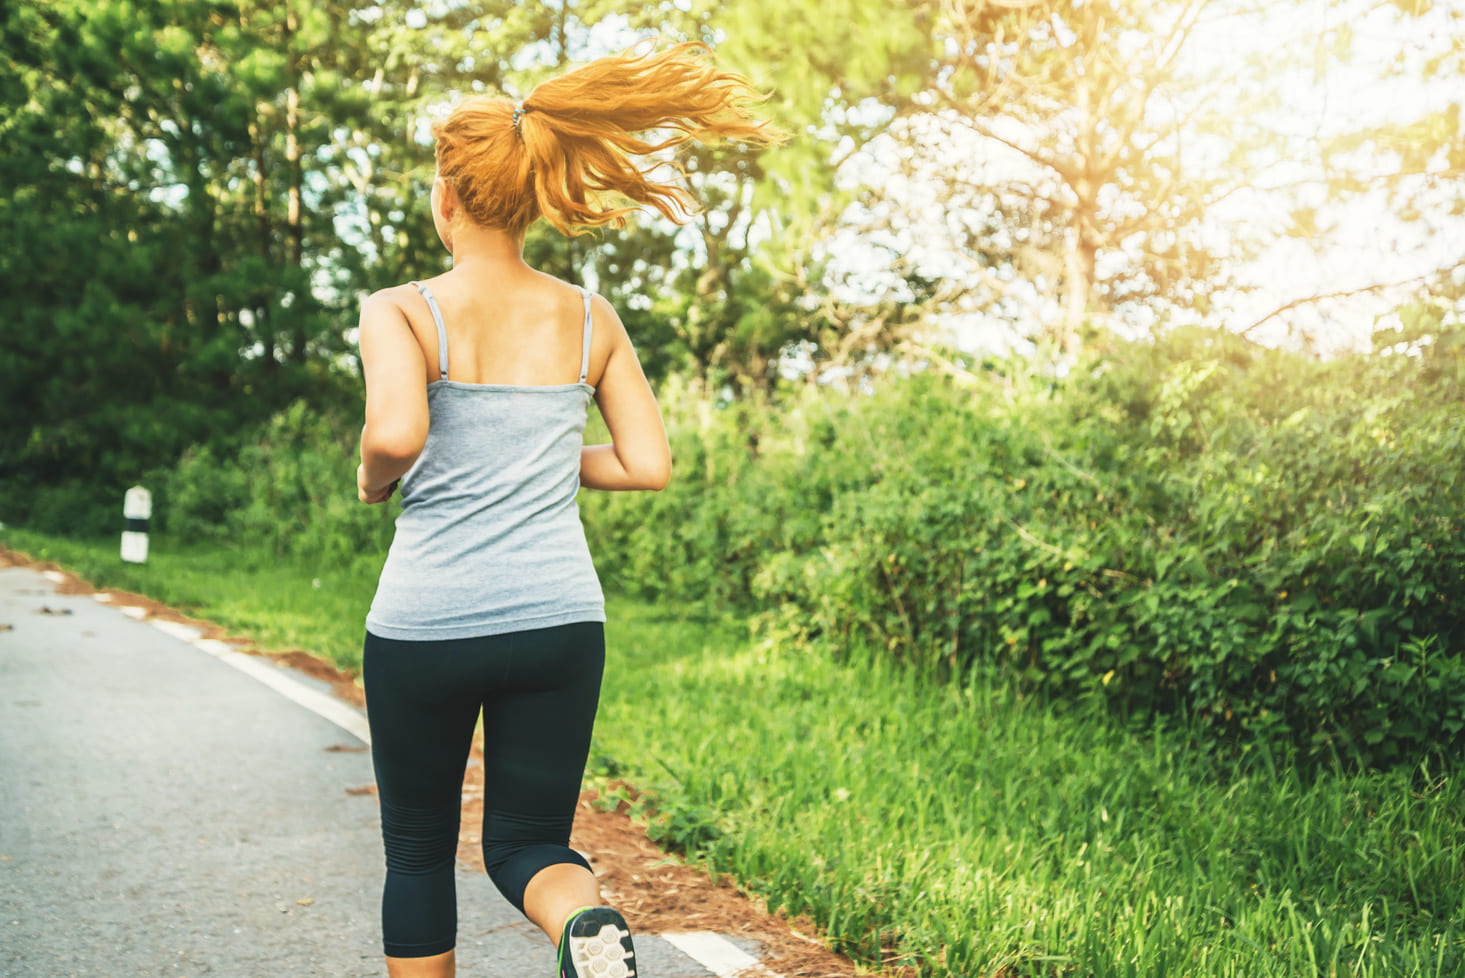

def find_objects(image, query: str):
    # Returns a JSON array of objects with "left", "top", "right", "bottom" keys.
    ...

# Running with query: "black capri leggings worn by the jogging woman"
[{"left": 362, "top": 622, "right": 605, "bottom": 958}]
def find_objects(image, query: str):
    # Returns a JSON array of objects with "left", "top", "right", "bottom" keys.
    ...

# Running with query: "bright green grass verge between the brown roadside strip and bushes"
[{"left": 0, "top": 530, "right": 1465, "bottom": 978}]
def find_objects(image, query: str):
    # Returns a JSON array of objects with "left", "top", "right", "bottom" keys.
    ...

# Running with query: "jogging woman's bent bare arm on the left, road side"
[{"left": 356, "top": 293, "right": 428, "bottom": 504}]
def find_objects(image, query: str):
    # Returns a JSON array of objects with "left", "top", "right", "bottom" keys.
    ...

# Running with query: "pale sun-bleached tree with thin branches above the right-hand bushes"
[{"left": 872, "top": 0, "right": 1276, "bottom": 353}]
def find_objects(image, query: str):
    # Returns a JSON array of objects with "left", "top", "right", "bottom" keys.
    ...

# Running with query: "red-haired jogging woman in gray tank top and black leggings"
[{"left": 356, "top": 44, "right": 769, "bottom": 978}]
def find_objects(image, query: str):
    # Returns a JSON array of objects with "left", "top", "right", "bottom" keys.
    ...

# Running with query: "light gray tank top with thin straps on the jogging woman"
[{"left": 366, "top": 283, "right": 605, "bottom": 640}]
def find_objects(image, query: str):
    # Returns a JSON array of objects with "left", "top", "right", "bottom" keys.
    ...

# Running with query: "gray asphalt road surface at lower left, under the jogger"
[{"left": 0, "top": 568, "right": 732, "bottom": 978}]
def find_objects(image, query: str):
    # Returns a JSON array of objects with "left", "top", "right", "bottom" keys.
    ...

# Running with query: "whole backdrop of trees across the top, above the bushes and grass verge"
[{"left": 0, "top": 0, "right": 1465, "bottom": 529}]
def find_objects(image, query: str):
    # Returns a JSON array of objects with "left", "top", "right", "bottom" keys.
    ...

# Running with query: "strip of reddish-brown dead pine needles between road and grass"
[{"left": 0, "top": 546, "right": 879, "bottom": 978}]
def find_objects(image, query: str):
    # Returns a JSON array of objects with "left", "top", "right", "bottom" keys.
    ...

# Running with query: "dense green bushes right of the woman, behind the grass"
[{"left": 583, "top": 329, "right": 1465, "bottom": 763}]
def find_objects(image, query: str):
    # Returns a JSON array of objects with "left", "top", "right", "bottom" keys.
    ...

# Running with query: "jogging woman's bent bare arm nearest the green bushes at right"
[{"left": 580, "top": 296, "right": 671, "bottom": 489}]
